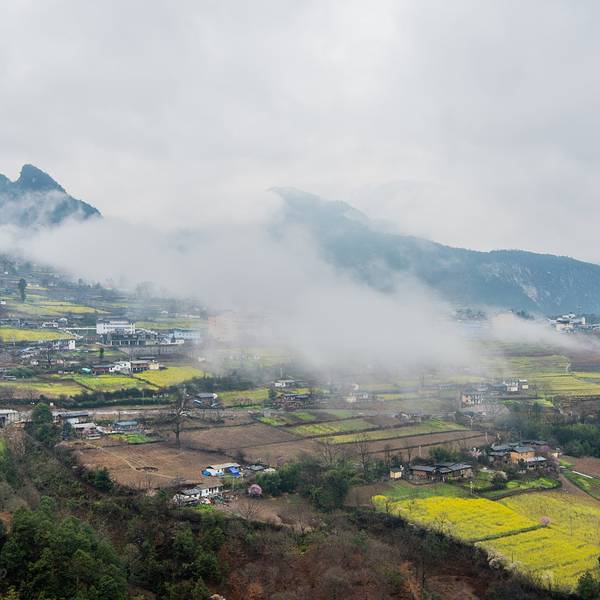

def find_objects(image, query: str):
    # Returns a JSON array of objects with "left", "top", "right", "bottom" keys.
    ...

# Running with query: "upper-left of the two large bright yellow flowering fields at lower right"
[{"left": 373, "top": 496, "right": 541, "bottom": 542}]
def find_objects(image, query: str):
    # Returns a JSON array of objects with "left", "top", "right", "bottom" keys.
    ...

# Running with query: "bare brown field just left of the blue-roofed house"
[{"left": 71, "top": 440, "right": 229, "bottom": 489}]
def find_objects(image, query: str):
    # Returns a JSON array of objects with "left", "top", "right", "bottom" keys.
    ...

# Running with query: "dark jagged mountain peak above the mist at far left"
[{"left": 0, "top": 164, "right": 101, "bottom": 227}]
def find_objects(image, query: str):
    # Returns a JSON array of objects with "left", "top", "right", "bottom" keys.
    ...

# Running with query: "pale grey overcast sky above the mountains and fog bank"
[{"left": 0, "top": 0, "right": 600, "bottom": 262}]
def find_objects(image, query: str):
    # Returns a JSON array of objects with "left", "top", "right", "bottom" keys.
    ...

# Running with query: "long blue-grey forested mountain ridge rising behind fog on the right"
[{"left": 273, "top": 188, "right": 600, "bottom": 314}]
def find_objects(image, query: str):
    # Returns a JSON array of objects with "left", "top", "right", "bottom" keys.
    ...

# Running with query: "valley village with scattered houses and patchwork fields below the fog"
[{"left": 0, "top": 258, "right": 600, "bottom": 587}]
